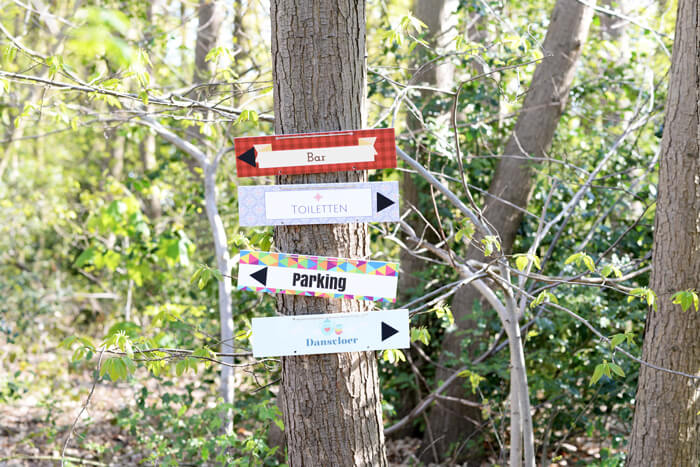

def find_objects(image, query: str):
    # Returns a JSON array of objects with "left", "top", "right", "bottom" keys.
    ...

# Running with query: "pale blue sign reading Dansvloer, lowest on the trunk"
[{"left": 252, "top": 310, "right": 411, "bottom": 357}]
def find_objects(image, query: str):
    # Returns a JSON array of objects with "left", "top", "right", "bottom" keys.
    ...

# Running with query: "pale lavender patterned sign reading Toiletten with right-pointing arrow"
[{"left": 238, "top": 182, "right": 399, "bottom": 226}]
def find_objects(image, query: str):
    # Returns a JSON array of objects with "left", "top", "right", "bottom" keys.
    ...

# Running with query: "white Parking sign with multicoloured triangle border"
[{"left": 237, "top": 250, "right": 399, "bottom": 302}]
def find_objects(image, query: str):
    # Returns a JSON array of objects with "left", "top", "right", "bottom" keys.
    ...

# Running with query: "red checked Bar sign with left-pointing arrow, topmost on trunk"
[{"left": 234, "top": 128, "right": 396, "bottom": 177}]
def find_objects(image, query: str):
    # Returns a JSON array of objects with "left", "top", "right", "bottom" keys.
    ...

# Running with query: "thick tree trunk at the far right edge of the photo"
[{"left": 627, "top": 0, "right": 700, "bottom": 467}]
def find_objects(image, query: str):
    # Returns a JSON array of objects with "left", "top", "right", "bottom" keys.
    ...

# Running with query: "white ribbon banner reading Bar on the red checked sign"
[{"left": 254, "top": 137, "right": 377, "bottom": 169}]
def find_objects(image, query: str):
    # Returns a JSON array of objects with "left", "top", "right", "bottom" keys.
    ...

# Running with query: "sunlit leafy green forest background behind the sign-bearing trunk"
[{"left": 0, "top": 0, "right": 700, "bottom": 466}]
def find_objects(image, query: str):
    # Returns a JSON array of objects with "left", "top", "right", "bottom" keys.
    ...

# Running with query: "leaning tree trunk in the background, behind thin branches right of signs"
[{"left": 430, "top": 0, "right": 593, "bottom": 460}]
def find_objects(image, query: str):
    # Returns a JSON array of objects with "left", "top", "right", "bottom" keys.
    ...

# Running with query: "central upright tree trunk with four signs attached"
[{"left": 270, "top": 0, "right": 387, "bottom": 466}]
